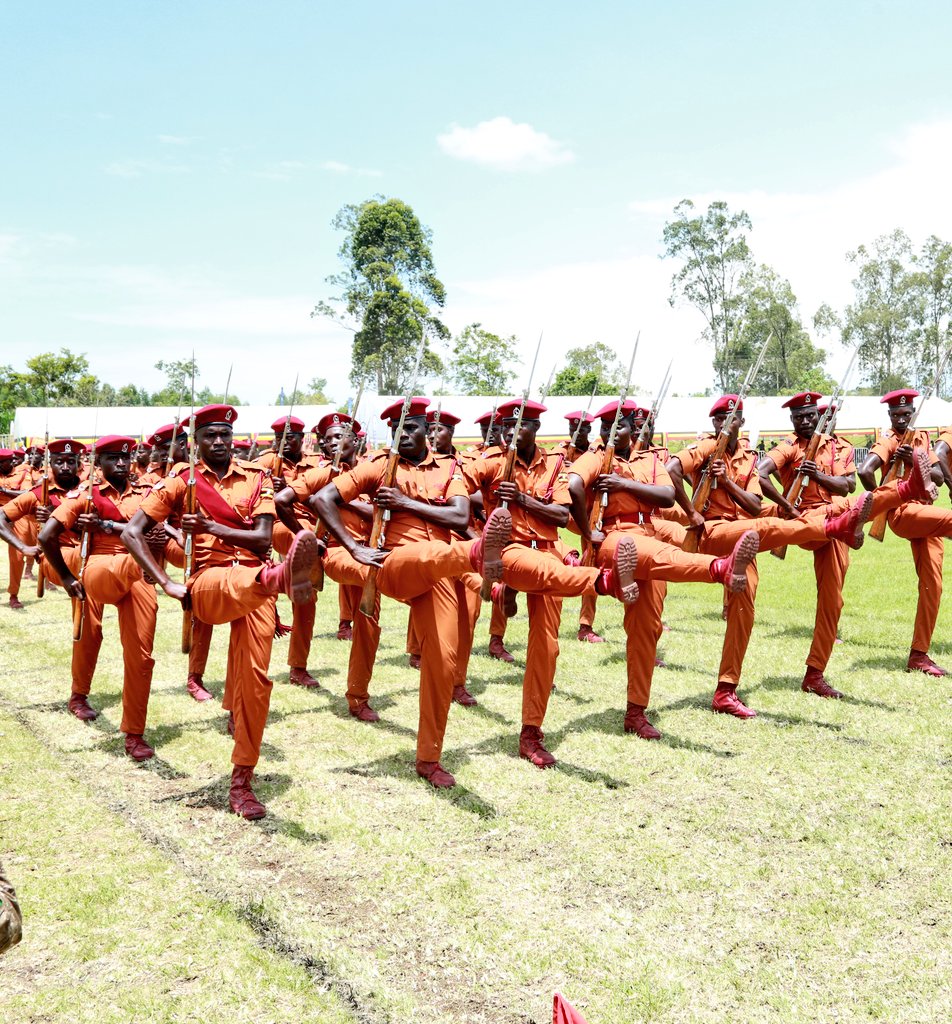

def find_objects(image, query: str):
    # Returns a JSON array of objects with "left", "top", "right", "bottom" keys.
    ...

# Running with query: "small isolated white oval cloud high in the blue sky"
[{"left": 436, "top": 117, "right": 575, "bottom": 171}]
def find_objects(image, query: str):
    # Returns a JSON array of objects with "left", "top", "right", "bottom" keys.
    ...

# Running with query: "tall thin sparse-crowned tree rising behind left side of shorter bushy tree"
[{"left": 662, "top": 199, "right": 751, "bottom": 391}]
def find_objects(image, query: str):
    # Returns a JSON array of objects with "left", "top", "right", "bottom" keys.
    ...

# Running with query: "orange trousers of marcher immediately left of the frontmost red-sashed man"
[{"left": 82, "top": 554, "right": 159, "bottom": 735}]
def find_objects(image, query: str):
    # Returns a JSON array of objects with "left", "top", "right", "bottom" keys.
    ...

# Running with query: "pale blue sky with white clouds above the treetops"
[{"left": 0, "top": 0, "right": 952, "bottom": 401}]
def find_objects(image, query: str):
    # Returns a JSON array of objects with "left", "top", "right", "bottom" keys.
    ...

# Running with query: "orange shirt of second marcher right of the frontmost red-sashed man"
[{"left": 463, "top": 444, "right": 571, "bottom": 544}]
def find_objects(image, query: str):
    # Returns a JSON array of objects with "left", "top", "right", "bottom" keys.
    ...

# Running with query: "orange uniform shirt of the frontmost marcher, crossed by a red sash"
[{"left": 142, "top": 459, "right": 275, "bottom": 569}]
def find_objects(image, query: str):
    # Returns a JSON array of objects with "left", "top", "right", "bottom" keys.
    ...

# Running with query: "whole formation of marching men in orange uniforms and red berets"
[{"left": 0, "top": 389, "right": 952, "bottom": 818}]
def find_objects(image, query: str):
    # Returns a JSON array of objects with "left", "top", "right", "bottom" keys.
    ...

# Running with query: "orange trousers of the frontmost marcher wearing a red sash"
[{"left": 188, "top": 565, "right": 276, "bottom": 766}]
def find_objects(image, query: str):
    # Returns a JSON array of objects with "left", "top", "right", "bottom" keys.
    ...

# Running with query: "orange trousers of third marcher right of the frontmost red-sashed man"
[{"left": 598, "top": 522, "right": 713, "bottom": 708}]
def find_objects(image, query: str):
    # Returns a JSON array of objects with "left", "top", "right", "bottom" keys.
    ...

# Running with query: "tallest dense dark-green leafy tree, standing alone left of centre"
[{"left": 311, "top": 196, "right": 449, "bottom": 394}]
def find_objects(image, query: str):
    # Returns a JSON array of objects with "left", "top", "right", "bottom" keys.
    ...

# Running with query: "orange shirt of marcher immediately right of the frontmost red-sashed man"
[{"left": 333, "top": 452, "right": 469, "bottom": 548}]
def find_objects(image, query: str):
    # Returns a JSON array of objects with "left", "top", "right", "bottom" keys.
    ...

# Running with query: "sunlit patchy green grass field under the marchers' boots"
[{"left": 0, "top": 535, "right": 952, "bottom": 1024}]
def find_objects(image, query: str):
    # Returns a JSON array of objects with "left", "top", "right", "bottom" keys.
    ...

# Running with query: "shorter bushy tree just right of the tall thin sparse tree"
[{"left": 732, "top": 263, "right": 835, "bottom": 394}]
